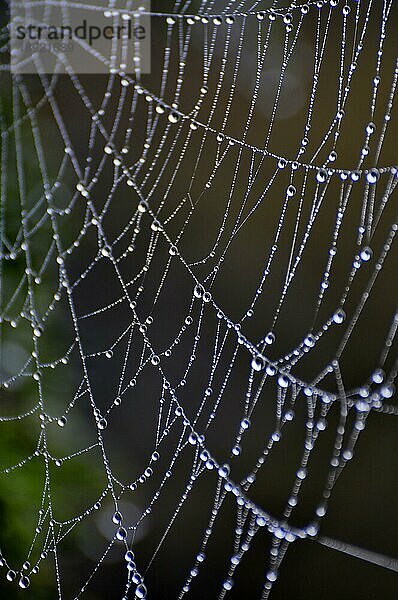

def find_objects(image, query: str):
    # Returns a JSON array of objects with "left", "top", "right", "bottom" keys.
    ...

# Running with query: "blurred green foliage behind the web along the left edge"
[{"left": 0, "top": 73, "right": 104, "bottom": 600}]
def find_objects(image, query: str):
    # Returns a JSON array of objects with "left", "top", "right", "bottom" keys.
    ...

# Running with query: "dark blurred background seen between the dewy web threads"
[{"left": 0, "top": 1, "right": 398, "bottom": 600}]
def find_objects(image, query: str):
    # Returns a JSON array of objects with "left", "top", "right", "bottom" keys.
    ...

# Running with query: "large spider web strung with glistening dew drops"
[{"left": 0, "top": 0, "right": 398, "bottom": 599}]
